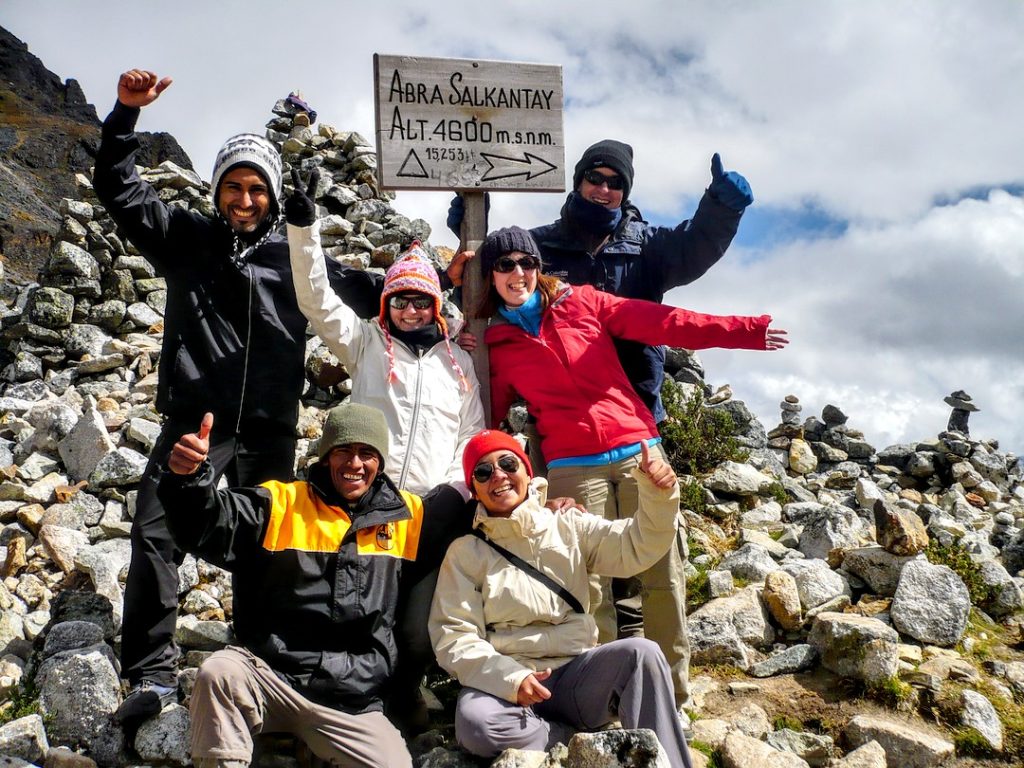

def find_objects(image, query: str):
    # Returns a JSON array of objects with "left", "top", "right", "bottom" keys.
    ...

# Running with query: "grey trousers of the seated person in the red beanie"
[{"left": 455, "top": 638, "right": 690, "bottom": 768}]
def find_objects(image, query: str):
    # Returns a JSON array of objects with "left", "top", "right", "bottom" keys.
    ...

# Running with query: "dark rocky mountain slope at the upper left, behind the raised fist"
[{"left": 0, "top": 27, "right": 191, "bottom": 286}]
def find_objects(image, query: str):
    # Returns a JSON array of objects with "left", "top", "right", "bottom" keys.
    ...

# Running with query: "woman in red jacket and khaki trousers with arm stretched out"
[{"left": 477, "top": 226, "right": 787, "bottom": 703}]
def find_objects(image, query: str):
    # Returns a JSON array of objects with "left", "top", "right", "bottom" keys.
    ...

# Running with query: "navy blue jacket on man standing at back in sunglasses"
[{"left": 530, "top": 194, "right": 741, "bottom": 422}]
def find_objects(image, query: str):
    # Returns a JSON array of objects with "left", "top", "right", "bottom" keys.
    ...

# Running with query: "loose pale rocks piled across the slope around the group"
[{"left": 0, "top": 101, "right": 1024, "bottom": 768}]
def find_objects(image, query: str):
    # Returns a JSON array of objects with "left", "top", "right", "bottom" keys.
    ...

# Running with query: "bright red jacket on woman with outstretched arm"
[{"left": 483, "top": 286, "right": 771, "bottom": 462}]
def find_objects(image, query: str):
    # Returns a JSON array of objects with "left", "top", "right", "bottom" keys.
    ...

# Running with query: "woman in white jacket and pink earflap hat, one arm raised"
[{"left": 285, "top": 171, "right": 484, "bottom": 500}]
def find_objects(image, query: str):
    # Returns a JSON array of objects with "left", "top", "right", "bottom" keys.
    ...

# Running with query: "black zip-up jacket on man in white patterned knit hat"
[{"left": 93, "top": 102, "right": 306, "bottom": 436}]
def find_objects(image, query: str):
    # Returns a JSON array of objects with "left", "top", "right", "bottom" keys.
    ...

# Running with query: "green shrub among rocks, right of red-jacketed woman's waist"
[{"left": 659, "top": 379, "right": 750, "bottom": 479}]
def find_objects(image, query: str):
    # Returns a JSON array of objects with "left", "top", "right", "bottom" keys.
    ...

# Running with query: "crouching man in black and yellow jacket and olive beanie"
[{"left": 158, "top": 403, "right": 460, "bottom": 768}]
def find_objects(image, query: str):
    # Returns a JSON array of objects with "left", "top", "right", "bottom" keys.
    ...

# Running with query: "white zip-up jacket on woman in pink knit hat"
[{"left": 288, "top": 222, "right": 483, "bottom": 499}]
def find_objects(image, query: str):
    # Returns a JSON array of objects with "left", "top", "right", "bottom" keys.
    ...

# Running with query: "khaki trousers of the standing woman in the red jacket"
[{"left": 548, "top": 445, "right": 690, "bottom": 705}]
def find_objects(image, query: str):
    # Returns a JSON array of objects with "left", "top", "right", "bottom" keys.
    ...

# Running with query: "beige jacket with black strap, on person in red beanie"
[{"left": 429, "top": 469, "right": 679, "bottom": 701}]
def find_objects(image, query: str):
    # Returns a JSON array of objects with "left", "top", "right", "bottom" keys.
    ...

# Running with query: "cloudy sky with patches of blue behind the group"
[{"left": 6, "top": 0, "right": 1024, "bottom": 454}]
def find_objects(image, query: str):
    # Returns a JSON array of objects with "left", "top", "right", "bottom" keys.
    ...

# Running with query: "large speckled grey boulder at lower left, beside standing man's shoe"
[{"left": 36, "top": 644, "right": 124, "bottom": 766}]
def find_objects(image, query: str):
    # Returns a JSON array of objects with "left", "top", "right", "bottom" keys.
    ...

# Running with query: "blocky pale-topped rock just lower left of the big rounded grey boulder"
[{"left": 808, "top": 611, "right": 899, "bottom": 683}]
